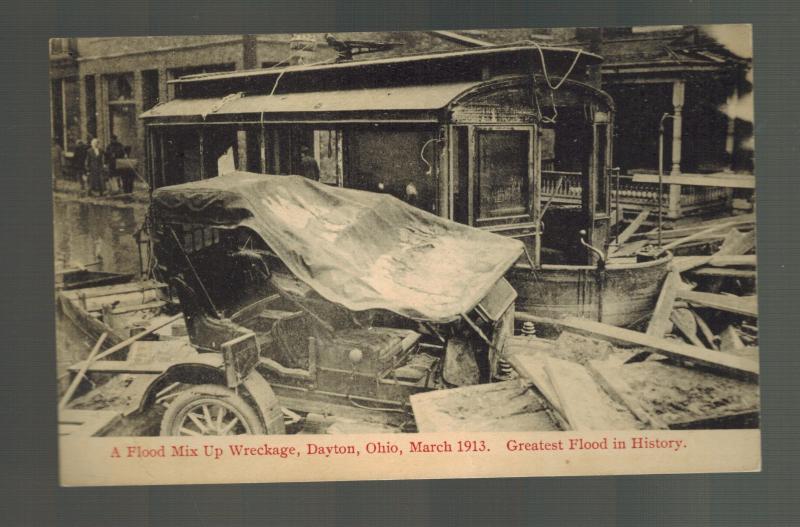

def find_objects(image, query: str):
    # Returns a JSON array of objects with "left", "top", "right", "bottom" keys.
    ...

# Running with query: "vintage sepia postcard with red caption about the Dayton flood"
[{"left": 50, "top": 25, "right": 761, "bottom": 486}]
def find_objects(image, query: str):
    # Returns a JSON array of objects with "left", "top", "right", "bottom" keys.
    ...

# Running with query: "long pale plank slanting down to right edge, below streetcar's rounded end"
[{"left": 515, "top": 312, "right": 758, "bottom": 384}]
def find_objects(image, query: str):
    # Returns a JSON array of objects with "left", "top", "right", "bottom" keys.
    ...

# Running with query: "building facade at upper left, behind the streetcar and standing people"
[{"left": 50, "top": 34, "right": 335, "bottom": 163}]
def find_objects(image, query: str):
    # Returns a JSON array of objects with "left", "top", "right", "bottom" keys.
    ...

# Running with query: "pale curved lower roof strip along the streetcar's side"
[{"left": 141, "top": 82, "right": 481, "bottom": 119}]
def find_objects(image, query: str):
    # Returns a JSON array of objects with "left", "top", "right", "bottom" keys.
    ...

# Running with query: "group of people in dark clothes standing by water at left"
[{"left": 73, "top": 135, "right": 135, "bottom": 196}]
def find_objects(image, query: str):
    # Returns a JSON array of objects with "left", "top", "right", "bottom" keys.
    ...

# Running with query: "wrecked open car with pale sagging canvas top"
[{"left": 142, "top": 172, "right": 523, "bottom": 435}]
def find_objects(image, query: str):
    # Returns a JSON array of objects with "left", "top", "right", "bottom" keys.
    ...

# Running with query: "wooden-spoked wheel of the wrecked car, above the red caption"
[{"left": 161, "top": 384, "right": 265, "bottom": 436}]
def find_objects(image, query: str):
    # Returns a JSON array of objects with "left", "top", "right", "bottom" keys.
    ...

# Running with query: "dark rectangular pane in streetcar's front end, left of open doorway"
[{"left": 477, "top": 130, "right": 530, "bottom": 221}]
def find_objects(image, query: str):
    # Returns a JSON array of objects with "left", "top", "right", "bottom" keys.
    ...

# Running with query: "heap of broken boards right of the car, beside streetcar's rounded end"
[{"left": 496, "top": 213, "right": 759, "bottom": 430}]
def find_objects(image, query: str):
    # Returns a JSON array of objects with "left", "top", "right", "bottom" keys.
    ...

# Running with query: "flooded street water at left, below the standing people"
[{"left": 53, "top": 197, "right": 147, "bottom": 274}]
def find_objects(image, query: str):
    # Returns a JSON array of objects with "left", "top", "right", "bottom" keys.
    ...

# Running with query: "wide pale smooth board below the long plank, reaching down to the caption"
[{"left": 544, "top": 357, "right": 638, "bottom": 431}]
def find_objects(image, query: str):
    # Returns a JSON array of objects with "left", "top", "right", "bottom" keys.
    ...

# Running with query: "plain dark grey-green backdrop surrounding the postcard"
[{"left": 0, "top": 0, "right": 800, "bottom": 527}]
